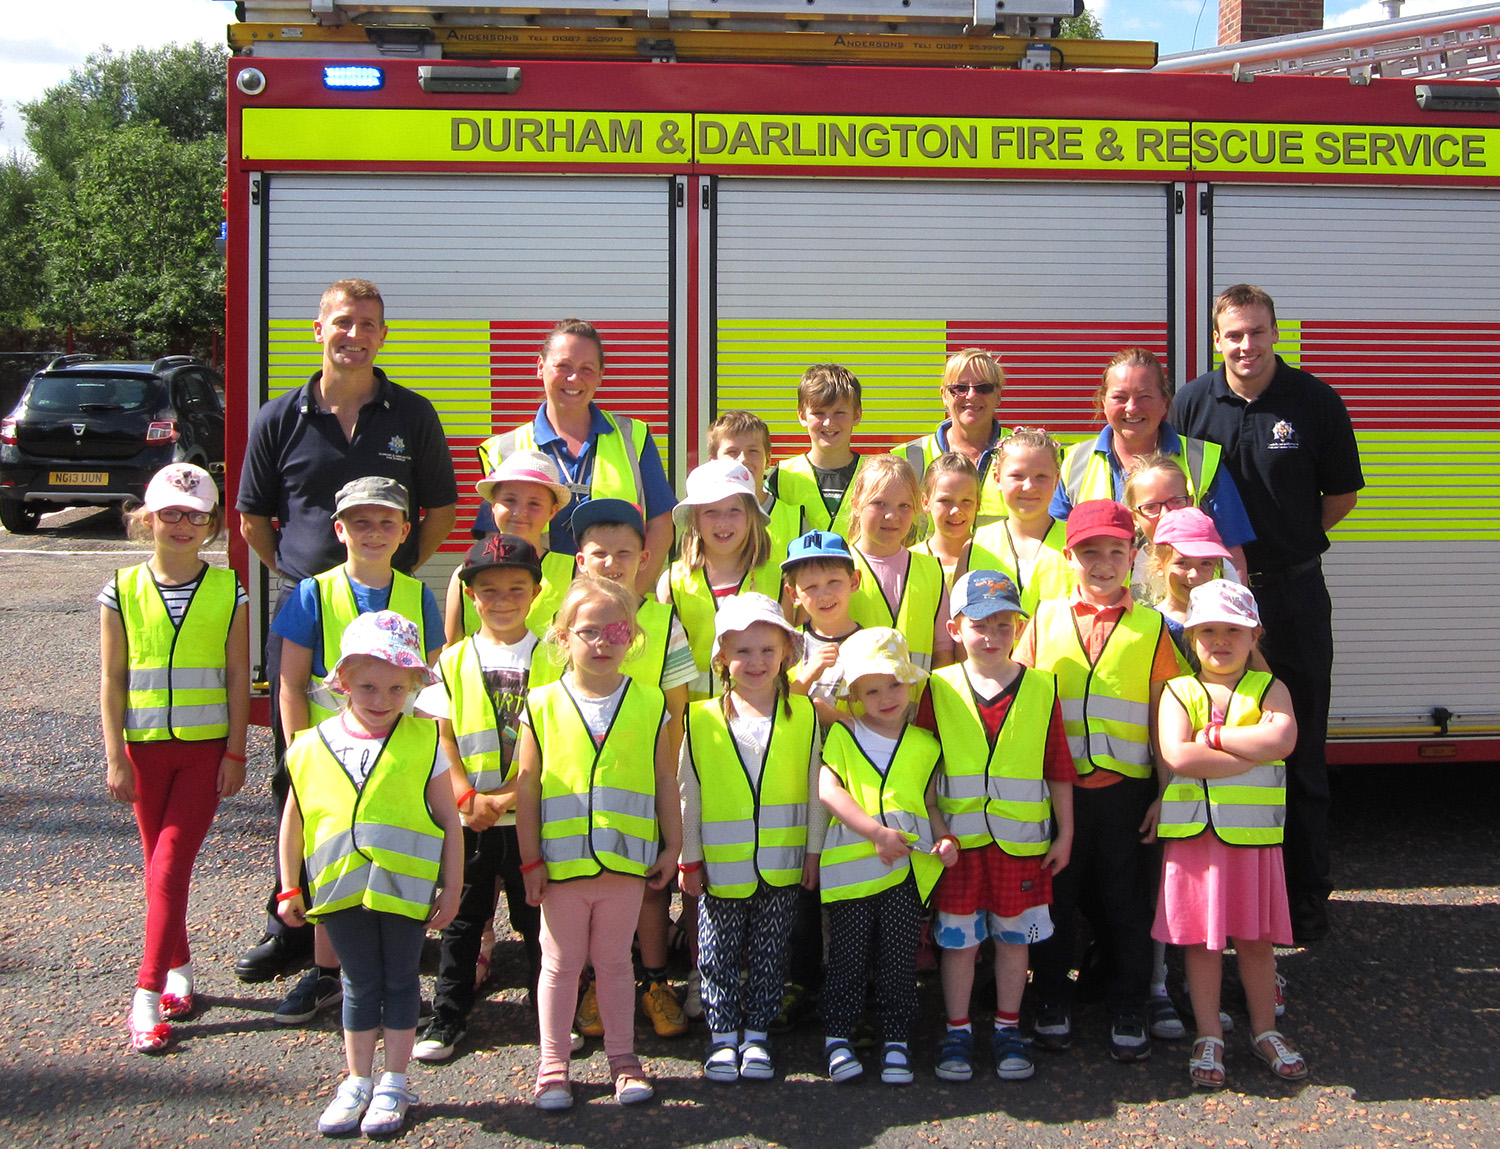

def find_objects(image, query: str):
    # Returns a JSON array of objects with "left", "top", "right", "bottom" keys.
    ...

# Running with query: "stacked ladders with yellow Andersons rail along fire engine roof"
[{"left": 230, "top": 0, "right": 1157, "bottom": 71}]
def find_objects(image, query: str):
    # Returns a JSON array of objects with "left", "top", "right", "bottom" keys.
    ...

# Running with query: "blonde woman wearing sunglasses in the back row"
[{"left": 894, "top": 347, "right": 1007, "bottom": 528}]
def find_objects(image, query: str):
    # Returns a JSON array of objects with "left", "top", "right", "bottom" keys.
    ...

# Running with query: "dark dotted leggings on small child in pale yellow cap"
[{"left": 824, "top": 873, "right": 923, "bottom": 1041}]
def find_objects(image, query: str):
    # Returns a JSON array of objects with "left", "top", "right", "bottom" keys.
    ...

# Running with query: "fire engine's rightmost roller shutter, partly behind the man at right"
[{"left": 1212, "top": 188, "right": 1500, "bottom": 734}]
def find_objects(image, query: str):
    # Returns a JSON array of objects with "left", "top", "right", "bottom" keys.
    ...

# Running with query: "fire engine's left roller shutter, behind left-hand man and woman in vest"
[{"left": 266, "top": 174, "right": 671, "bottom": 602}]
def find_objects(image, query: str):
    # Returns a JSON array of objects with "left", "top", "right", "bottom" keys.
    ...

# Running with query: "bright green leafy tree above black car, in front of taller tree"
[{"left": 39, "top": 123, "right": 224, "bottom": 354}]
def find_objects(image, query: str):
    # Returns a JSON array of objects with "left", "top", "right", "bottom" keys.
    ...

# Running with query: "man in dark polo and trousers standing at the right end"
[{"left": 1172, "top": 284, "right": 1365, "bottom": 944}]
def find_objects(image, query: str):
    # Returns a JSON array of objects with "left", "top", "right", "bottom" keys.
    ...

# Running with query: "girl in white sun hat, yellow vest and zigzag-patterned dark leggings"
[{"left": 678, "top": 594, "right": 828, "bottom": 1082}]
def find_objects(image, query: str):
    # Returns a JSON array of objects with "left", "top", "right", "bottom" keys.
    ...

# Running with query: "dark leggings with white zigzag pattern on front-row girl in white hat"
[{"left": 698, "top": 882, "right": 798, "bottom": 1034}]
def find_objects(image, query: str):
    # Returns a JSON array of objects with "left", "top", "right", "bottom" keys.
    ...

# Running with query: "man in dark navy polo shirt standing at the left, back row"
[{"left": 236, "top": 279, "right": 458, "bottom": 981}]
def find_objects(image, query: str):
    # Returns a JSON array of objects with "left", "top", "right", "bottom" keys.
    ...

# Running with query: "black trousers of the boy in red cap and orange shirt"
[{"left": 1031, "top": 779, "right": 1161, "bottom": 1016}]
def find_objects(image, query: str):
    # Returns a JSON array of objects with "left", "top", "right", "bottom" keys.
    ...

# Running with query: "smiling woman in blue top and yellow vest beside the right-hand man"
[{"left": 1052, "top": 347, "right": 1256, "bottom": 570}]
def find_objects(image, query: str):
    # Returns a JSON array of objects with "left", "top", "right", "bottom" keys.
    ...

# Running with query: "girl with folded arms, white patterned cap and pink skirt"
[{"left": 1152, "top": 579, "right": 1308, "bottom": 1089}]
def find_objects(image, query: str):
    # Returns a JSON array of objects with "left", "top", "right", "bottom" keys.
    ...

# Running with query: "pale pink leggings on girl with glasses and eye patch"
[{"left": 537, "top": 872, "right": 647, "bottom": 1082}]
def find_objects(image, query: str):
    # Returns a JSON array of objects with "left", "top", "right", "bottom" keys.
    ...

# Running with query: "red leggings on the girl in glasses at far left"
[{"left": 125, "top": 738, "right": 225, "bottom": 993}]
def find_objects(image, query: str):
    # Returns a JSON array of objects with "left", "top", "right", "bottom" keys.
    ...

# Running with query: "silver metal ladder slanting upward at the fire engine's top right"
[{"left": 1154, "top": 0, "right": 1500, "bottom": 83}]
